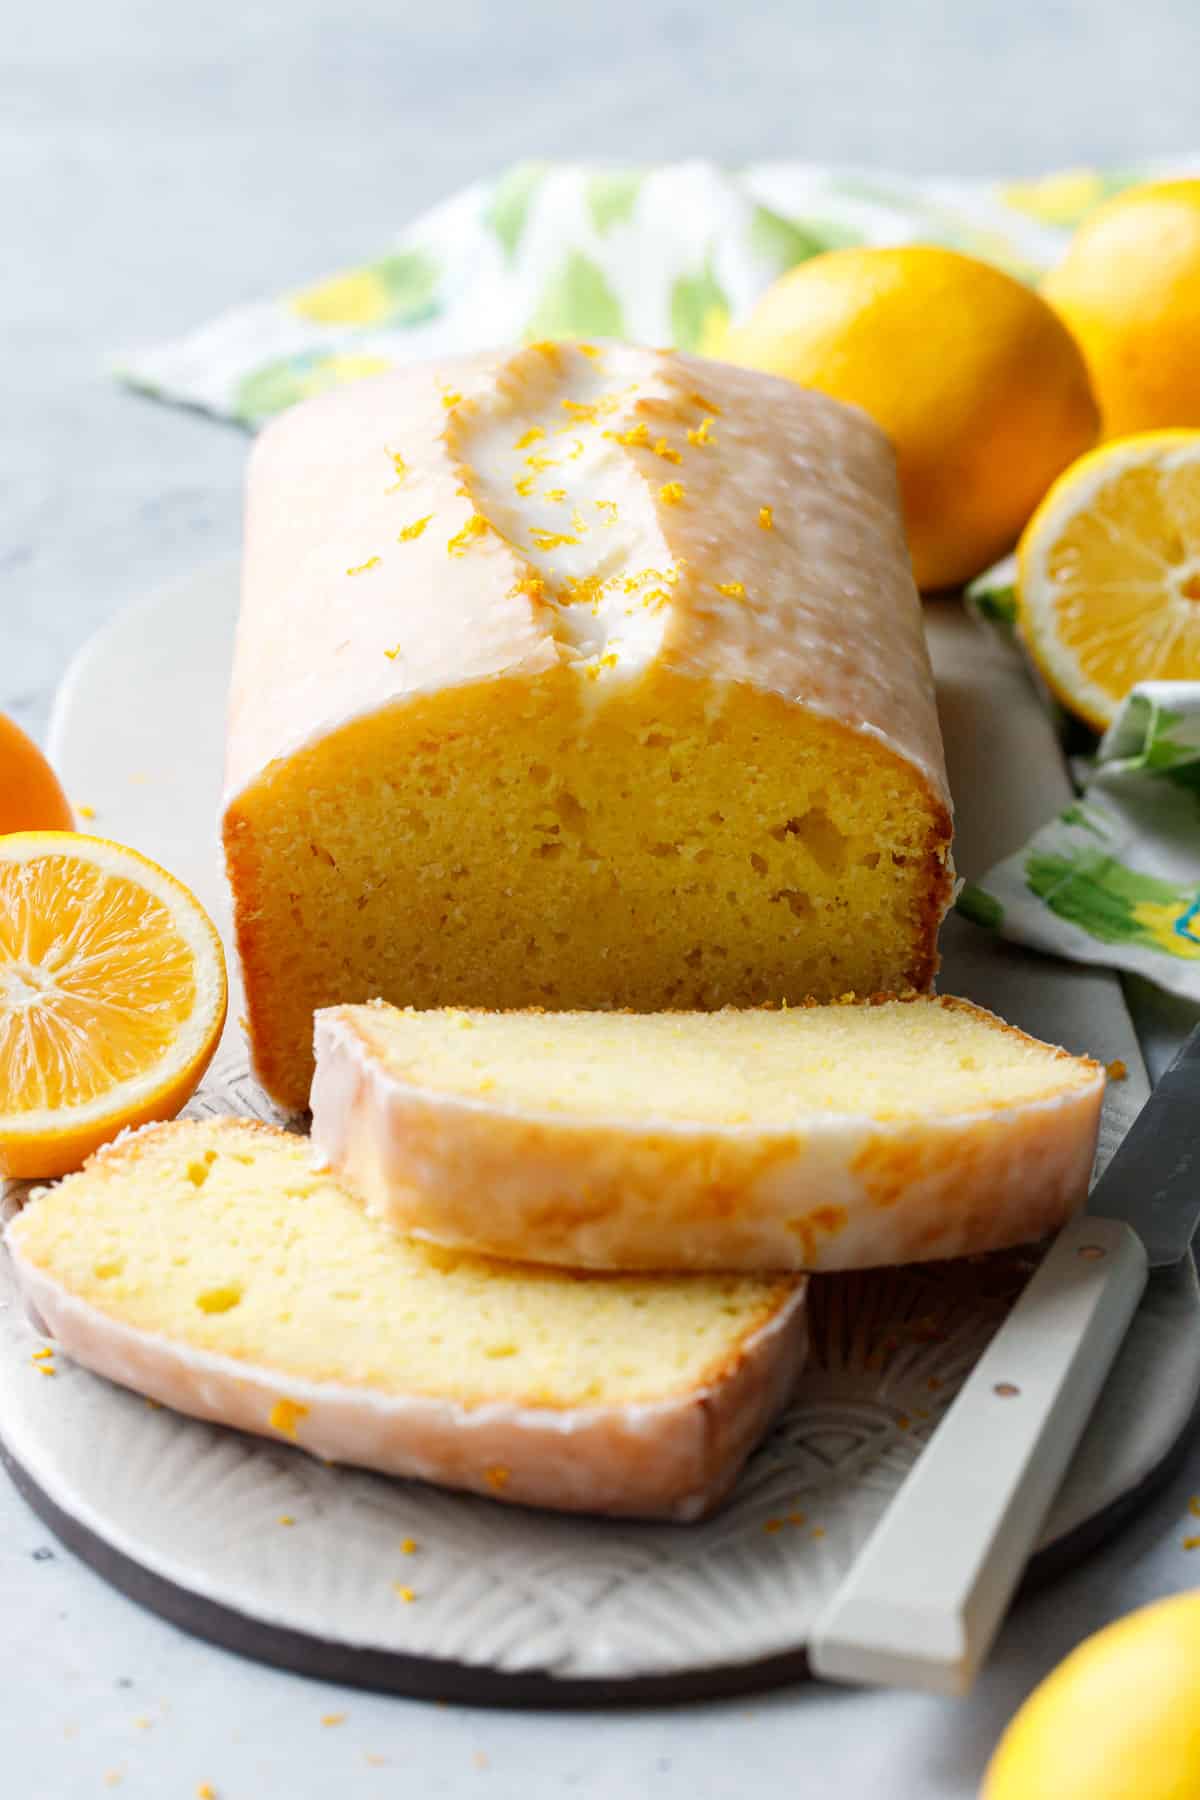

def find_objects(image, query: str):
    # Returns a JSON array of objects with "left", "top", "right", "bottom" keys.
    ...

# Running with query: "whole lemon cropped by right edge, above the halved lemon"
[{"left": 1042, "top": 180, "right": 1200, "bottom": 437}]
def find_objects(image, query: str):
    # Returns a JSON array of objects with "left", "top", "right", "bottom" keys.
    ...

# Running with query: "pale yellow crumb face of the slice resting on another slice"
[{"left": 353, "top": 999, "right": 1094, "bottom": 1129}]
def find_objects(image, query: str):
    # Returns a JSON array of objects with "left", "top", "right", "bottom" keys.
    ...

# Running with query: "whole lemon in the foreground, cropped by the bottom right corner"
[{"left": 981, "top": 1593, "right": 1200, "bottom": 1800}]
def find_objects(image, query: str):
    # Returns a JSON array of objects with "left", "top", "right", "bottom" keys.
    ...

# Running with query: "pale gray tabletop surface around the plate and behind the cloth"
[{"left": 0, "top": 0, "right": 1200, "bottom": 1800}]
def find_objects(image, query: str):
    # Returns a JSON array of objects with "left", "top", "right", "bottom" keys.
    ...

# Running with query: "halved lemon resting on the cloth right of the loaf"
[{"left": 1018, "top": 430, "right": 1200, "bottom": 731}]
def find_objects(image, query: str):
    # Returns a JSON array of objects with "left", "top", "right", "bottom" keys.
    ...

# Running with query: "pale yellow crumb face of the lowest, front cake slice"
[{"left": 14, "top": 1120, "right": 795, "bottom": 1408}]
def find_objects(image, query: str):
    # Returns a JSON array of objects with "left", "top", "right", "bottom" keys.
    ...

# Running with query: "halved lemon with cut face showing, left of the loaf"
[{"left": 0, "top": 832, "right": 227, "bottom": 1177}]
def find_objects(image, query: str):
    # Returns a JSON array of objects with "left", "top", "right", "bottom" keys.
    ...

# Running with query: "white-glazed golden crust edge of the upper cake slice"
[{"left": 313, "top": 999, "right": 1105, "bottom": 1271}]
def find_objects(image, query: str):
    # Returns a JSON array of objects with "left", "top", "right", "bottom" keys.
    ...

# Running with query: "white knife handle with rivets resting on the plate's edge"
[{"left": 808, "top": 1217, "right": 1146, "bottom": 1694}]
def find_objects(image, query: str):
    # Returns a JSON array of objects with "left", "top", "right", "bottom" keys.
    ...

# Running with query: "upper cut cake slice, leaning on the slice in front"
[{"left": 313, "top": 997, "right": 1105, "bottom": 1269}]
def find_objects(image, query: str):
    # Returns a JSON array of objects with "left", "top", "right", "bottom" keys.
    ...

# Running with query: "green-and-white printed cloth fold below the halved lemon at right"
[{"left": 959, "top": 682, "right": 1200, "bottom": 1001}]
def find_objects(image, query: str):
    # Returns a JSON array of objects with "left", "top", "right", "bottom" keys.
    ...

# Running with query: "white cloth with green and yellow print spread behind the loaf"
[{"left": 117, "top": 158, "right": 1200, "bottom": 427}]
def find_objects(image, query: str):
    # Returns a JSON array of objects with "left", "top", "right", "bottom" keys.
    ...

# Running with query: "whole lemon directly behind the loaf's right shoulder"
[{"left": 723, "top": 245, "right": 1099, "bottom": 589}]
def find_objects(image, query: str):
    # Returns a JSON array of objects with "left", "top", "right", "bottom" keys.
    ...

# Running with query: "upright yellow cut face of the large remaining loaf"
[{"left": 227, "top": 670, "right": 948, "bottom": 1107}]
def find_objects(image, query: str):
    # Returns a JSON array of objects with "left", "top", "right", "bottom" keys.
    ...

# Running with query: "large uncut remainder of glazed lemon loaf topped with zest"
[{"left": 223, "top": 331, "right": 950, "bottom": 1107}]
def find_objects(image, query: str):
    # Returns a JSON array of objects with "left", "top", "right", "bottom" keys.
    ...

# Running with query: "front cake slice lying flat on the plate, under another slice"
[{"left": 7, "top": 1120, "right": 806, "bottom": 1519}]
